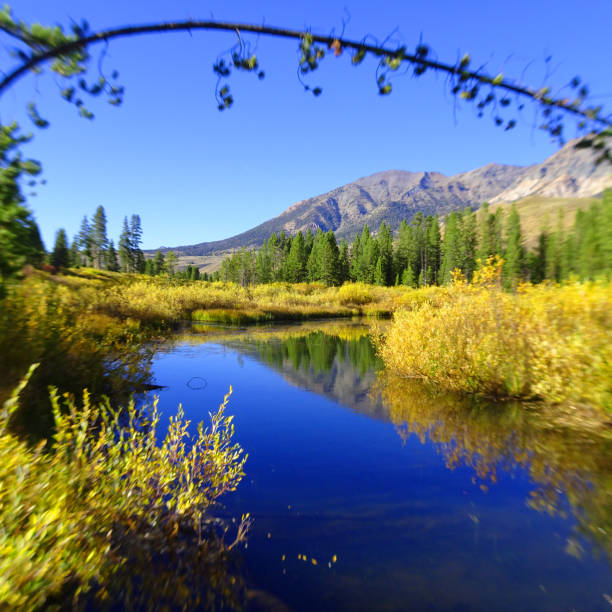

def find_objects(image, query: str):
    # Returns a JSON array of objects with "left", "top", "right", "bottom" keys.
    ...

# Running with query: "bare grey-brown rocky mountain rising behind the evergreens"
[{"left": 162, "top": 140, "right": 612, "bottom": 256}]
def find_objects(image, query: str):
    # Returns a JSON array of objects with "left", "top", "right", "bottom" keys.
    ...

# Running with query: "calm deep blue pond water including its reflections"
[{"left": 147, "top": 323, "right": 612, "bottom": 611}]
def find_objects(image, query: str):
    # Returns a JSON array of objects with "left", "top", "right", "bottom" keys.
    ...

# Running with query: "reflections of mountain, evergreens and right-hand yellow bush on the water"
[{"left": 209, "top": 324, "right": 612, "bottom": 559}]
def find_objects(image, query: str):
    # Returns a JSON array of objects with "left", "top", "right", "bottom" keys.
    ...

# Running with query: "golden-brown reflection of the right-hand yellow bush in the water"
[{"left": 373, "top": 374, "right": 612, "bottom": 559}]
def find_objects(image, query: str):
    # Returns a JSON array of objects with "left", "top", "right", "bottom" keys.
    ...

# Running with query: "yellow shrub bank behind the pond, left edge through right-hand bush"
[{"left": 0, "top": 266, "right": 612, "bottom": 410}]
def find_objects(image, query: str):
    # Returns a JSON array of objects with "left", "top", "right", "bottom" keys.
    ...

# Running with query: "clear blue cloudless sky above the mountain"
[{"left": 0, "top": 0, "right": 612, "bottom": 248}]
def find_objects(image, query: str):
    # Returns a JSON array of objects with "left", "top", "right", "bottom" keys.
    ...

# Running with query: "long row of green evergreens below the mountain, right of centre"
[{"left": 218, "top": 191, "right": 612, "bottom": 288}]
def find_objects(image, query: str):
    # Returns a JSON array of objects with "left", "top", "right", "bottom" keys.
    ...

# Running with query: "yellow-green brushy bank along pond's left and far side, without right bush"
[{"left": 0, "top": 269, "right": 406, "bottom": 438}]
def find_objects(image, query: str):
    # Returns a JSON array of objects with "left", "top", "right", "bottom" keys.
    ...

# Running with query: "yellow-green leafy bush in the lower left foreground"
[{"left": 0, "top": 366, "right": 248, "bottom": 609}]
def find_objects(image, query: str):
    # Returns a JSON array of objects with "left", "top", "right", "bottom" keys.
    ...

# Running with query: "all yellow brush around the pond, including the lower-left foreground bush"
[{"left": 0, "top": 260, "right": 612, "bottom": 607}]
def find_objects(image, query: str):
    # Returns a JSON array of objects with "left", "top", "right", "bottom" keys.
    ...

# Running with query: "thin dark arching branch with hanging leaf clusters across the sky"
[{"left": 0, "top": 10, "right": 612, "bottom": 159}]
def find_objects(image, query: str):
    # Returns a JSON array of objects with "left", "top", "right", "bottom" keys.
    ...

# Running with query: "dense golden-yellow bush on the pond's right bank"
[{"left": 378, "top": 262, "right": 612, "bottom": 410}]
